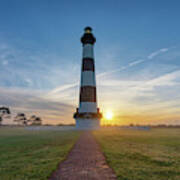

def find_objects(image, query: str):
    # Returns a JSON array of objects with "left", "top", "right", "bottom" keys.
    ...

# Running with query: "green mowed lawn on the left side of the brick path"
[{"left": 0, "top": 127, "right": 80, "bottom": 180}]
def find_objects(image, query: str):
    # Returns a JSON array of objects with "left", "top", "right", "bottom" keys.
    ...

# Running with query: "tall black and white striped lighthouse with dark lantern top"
[{"left": 74, "top": 27, "right": 102, "bottom": 129}]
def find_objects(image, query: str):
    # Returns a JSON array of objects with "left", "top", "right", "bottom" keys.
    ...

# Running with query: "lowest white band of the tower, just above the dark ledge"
[{"left": 79, "top": 102, "right": 97, "bottom": 113}]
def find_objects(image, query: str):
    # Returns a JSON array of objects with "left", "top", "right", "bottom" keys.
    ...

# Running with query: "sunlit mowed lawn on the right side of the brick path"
[{"left": 93, "top": 128, "right": 180, "bottom": 180}]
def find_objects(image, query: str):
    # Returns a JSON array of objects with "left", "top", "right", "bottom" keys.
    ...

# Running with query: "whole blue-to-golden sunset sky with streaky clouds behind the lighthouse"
[{"left": 0, "top": 0, "right": 180, "bottom": 124}]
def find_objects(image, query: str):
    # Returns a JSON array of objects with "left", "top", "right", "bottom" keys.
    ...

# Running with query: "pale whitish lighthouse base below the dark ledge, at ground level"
[{"left": 75, "top": 118, "right": 100, "bottom": 130}]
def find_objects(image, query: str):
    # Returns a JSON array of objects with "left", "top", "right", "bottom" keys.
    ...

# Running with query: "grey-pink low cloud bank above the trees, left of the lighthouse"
[{"left": 0, "top": 88, "right": 75, "bottom": 124}]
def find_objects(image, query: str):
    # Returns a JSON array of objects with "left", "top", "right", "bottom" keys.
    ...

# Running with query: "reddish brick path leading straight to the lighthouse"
[{"left": 49, "top": 131, "right": 117, "bottom": 180}]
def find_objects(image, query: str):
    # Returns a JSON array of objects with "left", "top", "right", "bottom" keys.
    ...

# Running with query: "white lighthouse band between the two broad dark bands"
[{"left": 81, "top": 71, "right": 96, "bottom": 86}]
